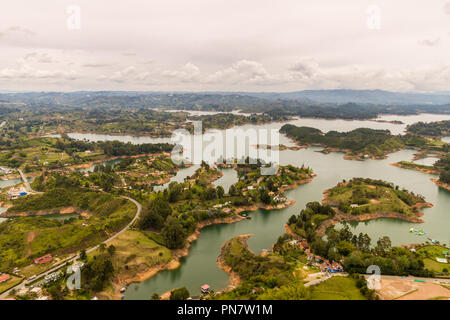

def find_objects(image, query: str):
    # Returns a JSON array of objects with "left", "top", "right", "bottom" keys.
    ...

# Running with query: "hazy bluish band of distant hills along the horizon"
[{"left": 0, "top": 89, "right": 450, "bottom": 110}]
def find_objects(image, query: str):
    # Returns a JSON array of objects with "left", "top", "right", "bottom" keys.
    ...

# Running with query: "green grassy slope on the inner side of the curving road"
[{"left": 0, "top": 194, "right": 136, "bottom": 274}]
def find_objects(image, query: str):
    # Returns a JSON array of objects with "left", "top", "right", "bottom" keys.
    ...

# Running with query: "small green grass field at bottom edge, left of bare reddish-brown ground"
[{"left": 311, "top": 277, "right": 366, "bottom": 300}]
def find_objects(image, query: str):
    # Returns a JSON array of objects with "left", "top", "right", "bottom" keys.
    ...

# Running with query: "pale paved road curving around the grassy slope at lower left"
[{"left": 0, "top": 195, "right": 142, "bottom": 299}]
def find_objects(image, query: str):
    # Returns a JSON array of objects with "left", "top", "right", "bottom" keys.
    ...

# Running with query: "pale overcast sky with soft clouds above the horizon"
[{"left": 0, "top": 0, "right": 450, "bottom": 91}]
